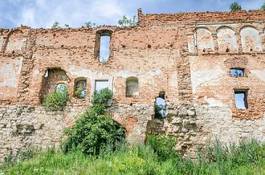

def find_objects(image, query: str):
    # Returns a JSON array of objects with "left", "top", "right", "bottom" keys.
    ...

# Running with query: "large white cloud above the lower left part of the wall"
[{"left": 16, "top": 0, "right": 127, "bottom": 27}]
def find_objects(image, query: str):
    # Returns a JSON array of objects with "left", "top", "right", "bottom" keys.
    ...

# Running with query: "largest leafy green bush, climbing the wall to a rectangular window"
[{"left": 62, "top": 89, "right": 125, "bottom": 155}]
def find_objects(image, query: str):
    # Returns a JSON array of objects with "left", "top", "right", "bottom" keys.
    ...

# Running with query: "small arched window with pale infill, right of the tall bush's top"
[{"left": 126, "top": 77, "right": 139, "bottom": 97}]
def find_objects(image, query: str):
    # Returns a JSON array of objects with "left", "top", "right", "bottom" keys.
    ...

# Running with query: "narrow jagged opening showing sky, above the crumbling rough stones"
[{"left": 155, "top": 91, "right": 167, "bottom": 119}]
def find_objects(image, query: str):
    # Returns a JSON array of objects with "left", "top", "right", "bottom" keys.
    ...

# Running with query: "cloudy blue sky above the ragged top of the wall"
[{"left": 0, "top": 0, "right": 265, "bottom": 28}]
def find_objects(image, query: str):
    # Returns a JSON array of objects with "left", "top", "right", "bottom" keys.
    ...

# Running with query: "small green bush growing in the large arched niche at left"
[{"left": 43, "top": 90, "right": 69, "bottom": 111}]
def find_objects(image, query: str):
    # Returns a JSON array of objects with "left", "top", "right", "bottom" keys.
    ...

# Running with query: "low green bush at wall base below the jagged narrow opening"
[{"left": 146, "top": 134, "right": 178, "bottom": 160}]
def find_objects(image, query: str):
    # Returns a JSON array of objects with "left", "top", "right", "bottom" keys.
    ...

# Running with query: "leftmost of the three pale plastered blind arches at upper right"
[{"left": 194, "top": 27, "right": 214, "bottom": 52}]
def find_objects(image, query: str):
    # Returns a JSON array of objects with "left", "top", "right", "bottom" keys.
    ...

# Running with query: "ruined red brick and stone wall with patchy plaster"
[{"left": 0, "top": 10, "right": 265, "bottom": 160}]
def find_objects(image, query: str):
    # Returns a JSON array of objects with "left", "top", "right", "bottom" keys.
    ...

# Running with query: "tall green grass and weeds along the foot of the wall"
[{"left": 0, "top": 141, "right": 265, "bottom": 175}]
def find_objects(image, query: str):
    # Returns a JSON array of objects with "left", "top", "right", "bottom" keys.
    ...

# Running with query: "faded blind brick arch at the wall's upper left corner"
[{"left": 4, "top": 29, "right": 27, "bottom": 52}]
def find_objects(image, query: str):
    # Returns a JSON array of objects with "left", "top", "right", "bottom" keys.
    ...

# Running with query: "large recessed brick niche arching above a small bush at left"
[{"left": 40, "top": 68, "right": 69, "bottom": 101}]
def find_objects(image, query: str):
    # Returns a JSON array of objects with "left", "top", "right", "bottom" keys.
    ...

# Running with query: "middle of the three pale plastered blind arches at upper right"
[{"left": 217, "top": 26, "right": 238, "bottom": 52}]
